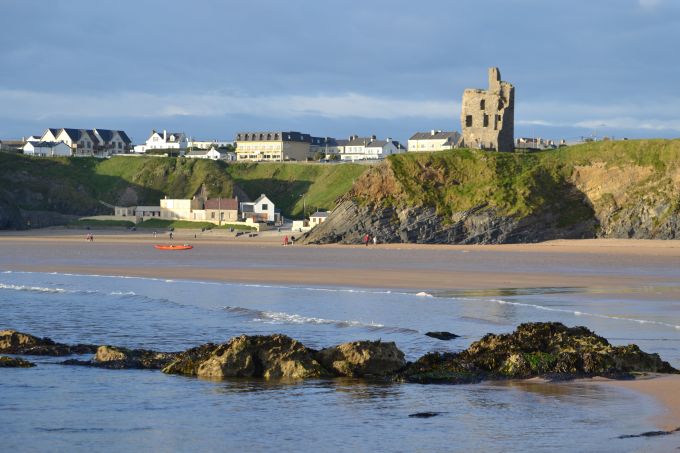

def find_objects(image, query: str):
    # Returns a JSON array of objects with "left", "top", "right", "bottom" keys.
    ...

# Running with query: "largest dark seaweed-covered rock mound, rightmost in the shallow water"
[{"left": 403, "top": 323, "right": 678, "bottom": 383}]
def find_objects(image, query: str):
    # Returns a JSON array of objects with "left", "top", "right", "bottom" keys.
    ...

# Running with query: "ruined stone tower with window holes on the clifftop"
[{"left": 460, "top": 68, "right": 515, "bottom": 151}]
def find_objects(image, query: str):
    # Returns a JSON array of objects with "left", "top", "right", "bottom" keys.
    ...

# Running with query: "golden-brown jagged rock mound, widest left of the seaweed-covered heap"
[{"left": 163, "top": 334, "right": 329, "bottom": 379}]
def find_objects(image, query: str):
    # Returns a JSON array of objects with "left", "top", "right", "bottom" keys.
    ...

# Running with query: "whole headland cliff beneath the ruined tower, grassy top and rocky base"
[{"left": 302, "top": 140, "right": 680, "bottom": 244}]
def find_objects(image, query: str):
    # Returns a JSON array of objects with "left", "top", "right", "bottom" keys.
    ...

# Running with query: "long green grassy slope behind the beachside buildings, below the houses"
[{"left": 0, "top": 153, "right": 367, "bottom": 223}]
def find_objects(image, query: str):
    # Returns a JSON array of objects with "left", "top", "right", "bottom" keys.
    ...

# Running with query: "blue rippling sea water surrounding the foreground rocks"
[{"left": 0, "top": 270, "right": 680, "bottom": 452}]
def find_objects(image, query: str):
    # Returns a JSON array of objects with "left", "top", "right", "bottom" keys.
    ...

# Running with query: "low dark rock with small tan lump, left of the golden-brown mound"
[{"left": 63, "top": 345, "right": 177, "bottom": 370}]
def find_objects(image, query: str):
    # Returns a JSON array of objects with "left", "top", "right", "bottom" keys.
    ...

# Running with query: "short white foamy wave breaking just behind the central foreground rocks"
[{"left": 223, "top": 306, "right": 419, "bottom": 334}]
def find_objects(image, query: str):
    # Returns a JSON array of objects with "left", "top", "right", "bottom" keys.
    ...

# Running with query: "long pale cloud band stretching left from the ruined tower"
[{"left": 0, "top": 90, "right": 460, "bottom": 120}]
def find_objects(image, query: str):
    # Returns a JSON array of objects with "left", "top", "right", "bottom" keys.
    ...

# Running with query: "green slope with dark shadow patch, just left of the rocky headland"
[{"left": 227, "top": 163, "right": 369, "bottom": 218}]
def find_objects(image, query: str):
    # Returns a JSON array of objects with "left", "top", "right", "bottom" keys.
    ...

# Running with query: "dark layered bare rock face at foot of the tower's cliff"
[{"left": 300, "top": 198, "right": 596, "bottom": 244}]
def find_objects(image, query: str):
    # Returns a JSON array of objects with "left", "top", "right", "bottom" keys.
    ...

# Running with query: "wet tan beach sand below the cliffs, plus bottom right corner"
[{"left": 0, "top": 229, "right": 680, "bottom": 430}]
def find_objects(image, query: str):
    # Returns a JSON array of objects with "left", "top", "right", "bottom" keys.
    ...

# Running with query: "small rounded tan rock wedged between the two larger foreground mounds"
[{"left": 316, "top": 340, "right": 406, "bottom": 377}]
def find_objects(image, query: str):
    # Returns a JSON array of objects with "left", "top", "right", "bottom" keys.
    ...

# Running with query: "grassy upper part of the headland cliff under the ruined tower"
[{"left": 353, "top": 140, "right": 680, "bottom": 231}]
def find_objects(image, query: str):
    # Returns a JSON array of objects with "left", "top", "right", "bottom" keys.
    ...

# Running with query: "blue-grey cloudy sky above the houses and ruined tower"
[{"left": 0, "top": 0, "right": 680, "bottom": 143}]
